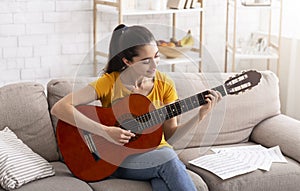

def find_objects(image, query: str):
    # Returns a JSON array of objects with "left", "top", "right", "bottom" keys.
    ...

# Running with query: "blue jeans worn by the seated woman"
[{"left": 113, "top": 147, "right": 196, "bottom": 191}]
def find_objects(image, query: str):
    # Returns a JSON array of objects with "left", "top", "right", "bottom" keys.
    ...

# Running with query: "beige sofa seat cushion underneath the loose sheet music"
[{"left": 178, "top": 142, "right": 300, "bottom": 191}]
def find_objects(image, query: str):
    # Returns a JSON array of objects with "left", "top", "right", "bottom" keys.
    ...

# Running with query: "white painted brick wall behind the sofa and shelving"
[{"left": 0, "top": 0, "right": 232, "bottom": 85}]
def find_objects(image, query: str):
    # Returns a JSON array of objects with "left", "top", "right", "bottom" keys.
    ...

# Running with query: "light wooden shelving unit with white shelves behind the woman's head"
[{"left": 93, "top": 0, "right": 203, "bottom": 75}]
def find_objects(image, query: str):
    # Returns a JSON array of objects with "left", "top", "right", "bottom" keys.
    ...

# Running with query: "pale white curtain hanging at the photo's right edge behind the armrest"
[{"left": 279, "top": 0, "right": 300, "bottom": 120}]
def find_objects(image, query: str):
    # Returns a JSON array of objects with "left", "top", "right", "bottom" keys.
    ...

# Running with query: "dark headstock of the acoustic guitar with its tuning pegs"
[{"left": 224, "top": 70, "right": 261, "bottom": 95}]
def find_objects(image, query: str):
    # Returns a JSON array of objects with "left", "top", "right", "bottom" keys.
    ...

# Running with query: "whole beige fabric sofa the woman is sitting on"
[{"left": 0, "top": 71, "right": 300, "bottom": 191}]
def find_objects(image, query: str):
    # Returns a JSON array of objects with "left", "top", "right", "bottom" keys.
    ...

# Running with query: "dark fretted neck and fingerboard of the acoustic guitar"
[{"left": 122, "top": 85, "right": 227, "bottom": 132}]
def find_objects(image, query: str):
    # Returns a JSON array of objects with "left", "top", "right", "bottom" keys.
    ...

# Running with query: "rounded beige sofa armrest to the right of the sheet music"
[{"left": 250, "top": 114, "right": 300, "bottom": 162}]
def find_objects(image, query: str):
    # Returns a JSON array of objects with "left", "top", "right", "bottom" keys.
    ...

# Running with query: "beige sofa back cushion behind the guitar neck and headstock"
[{"left": 169, "top": 71, "right": 280, "bottom": 149}]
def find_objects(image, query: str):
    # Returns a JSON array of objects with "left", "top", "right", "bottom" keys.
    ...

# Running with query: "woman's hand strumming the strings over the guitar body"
[{"left": 105, "top": 126, "right": 135, "bottom": 145}]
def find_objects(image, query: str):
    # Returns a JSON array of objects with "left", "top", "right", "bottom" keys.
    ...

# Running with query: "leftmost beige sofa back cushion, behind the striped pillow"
[{"left": 0, "top": 82, "right": 58, "bottom": 161}]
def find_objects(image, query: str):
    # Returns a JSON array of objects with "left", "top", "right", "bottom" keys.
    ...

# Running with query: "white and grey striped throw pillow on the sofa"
[{"left": 0, "top": 127, "right": 55, "bottom": 190}]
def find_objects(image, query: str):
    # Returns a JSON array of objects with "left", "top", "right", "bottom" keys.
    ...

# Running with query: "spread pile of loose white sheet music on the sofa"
[{"left": 189, "top": 145, "right": 287, "bottom": 180}]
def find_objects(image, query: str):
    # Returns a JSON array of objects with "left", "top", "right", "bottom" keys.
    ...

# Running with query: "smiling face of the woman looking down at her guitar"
[{"left": 129, "top": 43, "right": 160, "bottom": 78}]
